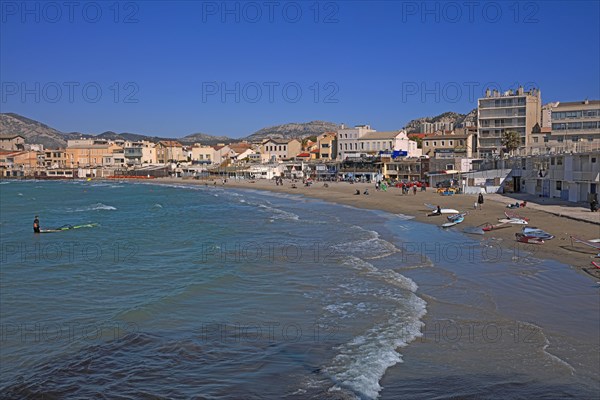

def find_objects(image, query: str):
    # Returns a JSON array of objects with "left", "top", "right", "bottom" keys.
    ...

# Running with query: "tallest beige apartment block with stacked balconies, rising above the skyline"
[{"left": 477, "top": 87, "right": 542, "bottom": 158}]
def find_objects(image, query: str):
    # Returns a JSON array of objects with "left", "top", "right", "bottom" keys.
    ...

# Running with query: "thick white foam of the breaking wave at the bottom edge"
[{"left": 324, "top": 293, "right": 427, "bottom": 399}]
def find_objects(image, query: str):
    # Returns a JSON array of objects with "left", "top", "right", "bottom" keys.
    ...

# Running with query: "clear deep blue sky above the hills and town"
[{"left": 0, "top": 1, "right": 600, "bottom": 137}]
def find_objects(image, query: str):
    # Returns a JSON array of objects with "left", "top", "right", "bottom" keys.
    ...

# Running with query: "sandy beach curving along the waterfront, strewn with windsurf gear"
[{"left": 153, "top": 178, "right": 600, "bottom": 279}]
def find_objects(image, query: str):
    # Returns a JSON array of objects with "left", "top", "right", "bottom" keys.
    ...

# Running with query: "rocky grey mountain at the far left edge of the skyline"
[{"left": 0, "top": 113, "right": 73, "bottom": 148}]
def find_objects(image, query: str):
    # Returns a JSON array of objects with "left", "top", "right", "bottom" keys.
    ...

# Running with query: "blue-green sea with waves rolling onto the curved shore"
[{"left": 0, "top": 180, "right": 600, "bottom": 399}]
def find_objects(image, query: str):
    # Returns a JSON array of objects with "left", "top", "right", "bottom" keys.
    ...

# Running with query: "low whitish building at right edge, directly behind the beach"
[{"left": 509, "top": 152, "right": 600, "bottom": 202}]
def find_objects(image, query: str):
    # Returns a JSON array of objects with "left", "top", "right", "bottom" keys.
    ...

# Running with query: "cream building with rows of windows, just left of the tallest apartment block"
[{"left": 422, "top": 130, "right": 477, "bottom": 158}]
